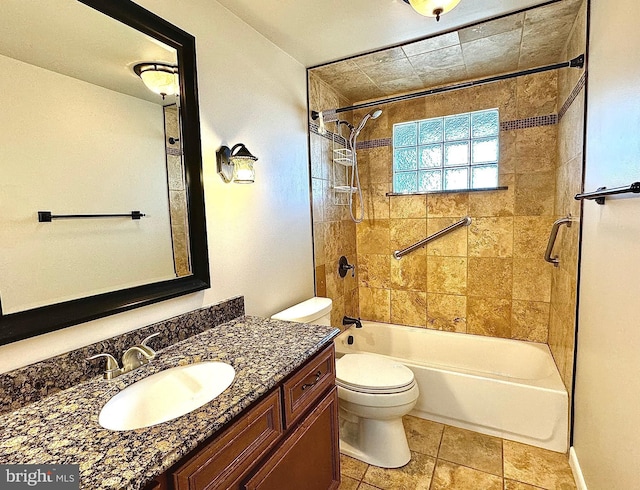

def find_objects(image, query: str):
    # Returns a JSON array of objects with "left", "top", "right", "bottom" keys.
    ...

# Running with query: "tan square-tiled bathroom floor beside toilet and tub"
[{"left": 339, "top": 416, "right": 576, "bottom": 490}]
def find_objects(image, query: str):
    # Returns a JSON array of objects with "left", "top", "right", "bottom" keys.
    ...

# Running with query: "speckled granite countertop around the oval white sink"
[{"left": 0, "top": 317, "right": 339, "bottom": 489}]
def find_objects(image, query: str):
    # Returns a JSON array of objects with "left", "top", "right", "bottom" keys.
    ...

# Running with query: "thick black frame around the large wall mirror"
[{"left": 0, "top": 0, "right": 210, "bottom": 345}]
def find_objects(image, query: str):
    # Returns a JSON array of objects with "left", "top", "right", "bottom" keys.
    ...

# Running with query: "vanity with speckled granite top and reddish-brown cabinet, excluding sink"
[{"left": 0, "top": 316, "right": 339, "bottom": 490}]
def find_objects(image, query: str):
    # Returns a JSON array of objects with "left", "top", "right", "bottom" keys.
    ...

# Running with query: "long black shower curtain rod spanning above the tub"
[{"left": 311, "top": 54, "right": 584, "bottom": 121}]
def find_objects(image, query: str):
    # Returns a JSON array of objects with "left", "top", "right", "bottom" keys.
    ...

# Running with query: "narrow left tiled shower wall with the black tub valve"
[{"left": 309, "top": 74, "right": 359, "bottom": 327}]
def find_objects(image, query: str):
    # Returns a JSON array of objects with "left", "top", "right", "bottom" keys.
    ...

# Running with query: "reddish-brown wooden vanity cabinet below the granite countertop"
[{"left": 144, "top": 345, "right": 340, "bottom": 490}]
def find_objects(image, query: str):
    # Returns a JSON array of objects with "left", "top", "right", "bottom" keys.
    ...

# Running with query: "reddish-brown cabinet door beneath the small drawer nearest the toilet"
[{"left": 245, "top": 387, "right": 340, "bottom": 490}]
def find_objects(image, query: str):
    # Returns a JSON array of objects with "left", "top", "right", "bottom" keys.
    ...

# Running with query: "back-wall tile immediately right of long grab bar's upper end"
[{"left": 469, "top": 217, "right": 513, "bottom": 257}]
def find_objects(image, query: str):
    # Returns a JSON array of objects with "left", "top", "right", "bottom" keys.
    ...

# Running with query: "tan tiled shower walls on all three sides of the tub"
[{"left": 310, "top": 21, "right": 584, "bottom": 346}]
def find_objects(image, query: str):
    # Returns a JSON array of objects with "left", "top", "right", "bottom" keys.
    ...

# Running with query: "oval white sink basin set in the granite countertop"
[{"left": 98, "top": 361, "right": 236, "bottom": 430}]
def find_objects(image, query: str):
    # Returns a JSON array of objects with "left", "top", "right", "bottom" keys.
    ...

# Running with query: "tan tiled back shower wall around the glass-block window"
[{"left": 354, "top": 72, "right": 557, "bottom": 342}]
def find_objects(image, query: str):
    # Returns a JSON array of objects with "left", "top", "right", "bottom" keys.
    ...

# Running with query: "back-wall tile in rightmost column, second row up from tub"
[{"left": 513, "top": 259, "right": 553, "bottom": 303}]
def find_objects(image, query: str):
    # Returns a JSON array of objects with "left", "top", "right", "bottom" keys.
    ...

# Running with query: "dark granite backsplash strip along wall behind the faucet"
[{"left": 0, "top": 296, "right": 245, "bottom": 413}]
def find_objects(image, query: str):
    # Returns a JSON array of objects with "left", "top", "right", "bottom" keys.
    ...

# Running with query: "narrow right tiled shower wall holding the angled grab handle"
[{"left": 549, "top": 2, "right": 587, "bottom": 393}]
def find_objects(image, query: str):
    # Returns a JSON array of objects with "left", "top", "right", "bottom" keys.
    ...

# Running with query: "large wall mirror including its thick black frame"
[{"left": 0, "top": 0, "right": 210, "bottom": 344}]
